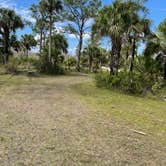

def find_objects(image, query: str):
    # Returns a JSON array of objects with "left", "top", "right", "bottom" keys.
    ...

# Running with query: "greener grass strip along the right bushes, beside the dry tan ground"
[{"left": 74, "top": 83, "right": 166, "bottom": 144}]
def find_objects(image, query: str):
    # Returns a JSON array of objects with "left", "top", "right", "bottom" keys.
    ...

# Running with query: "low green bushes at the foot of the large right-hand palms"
[{"left": 95, "top": 71, "right": 155, "bottom": 94}]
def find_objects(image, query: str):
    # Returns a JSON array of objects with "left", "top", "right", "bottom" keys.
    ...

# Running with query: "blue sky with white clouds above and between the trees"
[{"left": 0, "top": 0, "right": 166, "bottom": 54}]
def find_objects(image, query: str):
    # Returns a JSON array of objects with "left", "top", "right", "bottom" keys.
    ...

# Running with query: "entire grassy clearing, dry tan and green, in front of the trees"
[{"left": 0, "top": 75, "right": 166, "bottom": 166}]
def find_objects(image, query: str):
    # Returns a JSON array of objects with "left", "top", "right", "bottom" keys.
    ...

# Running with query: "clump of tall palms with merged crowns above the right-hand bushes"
[{"left": 93, "top": 0, "right": 149, "bottom": 74}]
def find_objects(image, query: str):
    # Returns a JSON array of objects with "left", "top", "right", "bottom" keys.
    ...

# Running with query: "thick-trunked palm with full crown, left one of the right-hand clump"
[{"left": 93, "top": 0, "right": 124, "bottom": 74}]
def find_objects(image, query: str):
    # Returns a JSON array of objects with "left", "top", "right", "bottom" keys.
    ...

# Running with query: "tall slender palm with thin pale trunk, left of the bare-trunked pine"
[{"left": 41, "top": 0, "right": 63, "bottom": 62}]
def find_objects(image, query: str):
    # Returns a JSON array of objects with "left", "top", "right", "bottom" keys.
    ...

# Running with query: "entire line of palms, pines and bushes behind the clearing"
[{"left": 0, "top": 0, "right": 166, "bottom": 93}]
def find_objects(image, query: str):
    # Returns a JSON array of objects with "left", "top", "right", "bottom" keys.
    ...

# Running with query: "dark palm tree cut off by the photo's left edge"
[{"left": 0, "top": 8, "right": 24, "bottom": 64}]
